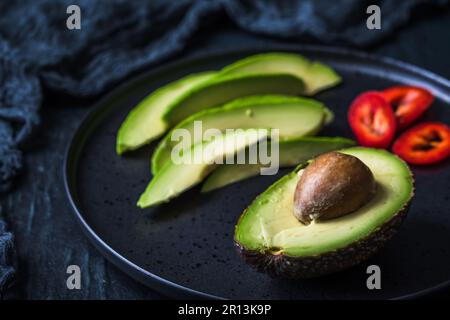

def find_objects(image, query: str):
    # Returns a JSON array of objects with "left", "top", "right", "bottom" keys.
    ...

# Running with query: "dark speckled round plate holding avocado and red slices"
[{"left": 65, "top": 47, "right": 450, "bottom": 299}]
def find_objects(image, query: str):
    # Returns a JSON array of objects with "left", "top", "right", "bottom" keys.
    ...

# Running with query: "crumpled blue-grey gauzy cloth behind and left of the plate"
[{"left": 0, "top": 0, "right": 449, "bottom": 293}]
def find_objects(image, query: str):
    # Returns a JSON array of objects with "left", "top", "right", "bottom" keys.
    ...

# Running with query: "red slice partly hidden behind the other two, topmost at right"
[{"left": 381, "top": 86, "right": 434, "bottom": 130}]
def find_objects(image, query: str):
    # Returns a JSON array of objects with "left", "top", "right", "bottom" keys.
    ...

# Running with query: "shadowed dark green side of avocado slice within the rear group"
[{"left": 163, "top": 73, "right": 304, "bottom": 126}]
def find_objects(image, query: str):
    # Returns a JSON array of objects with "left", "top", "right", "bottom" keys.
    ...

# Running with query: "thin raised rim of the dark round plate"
[{"left": 63, "top": 44, "right": 450, "bottom": 300}]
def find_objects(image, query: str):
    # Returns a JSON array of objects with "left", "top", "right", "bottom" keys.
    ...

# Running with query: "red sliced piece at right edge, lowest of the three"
[{"left": 392, "top": 122, "right": 450, "bottom": 164}]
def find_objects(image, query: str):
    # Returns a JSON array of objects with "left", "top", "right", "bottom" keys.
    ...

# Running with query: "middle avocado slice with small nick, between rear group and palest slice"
[{"left": 152, "top": 95, "right": 331, "bottom": 174}]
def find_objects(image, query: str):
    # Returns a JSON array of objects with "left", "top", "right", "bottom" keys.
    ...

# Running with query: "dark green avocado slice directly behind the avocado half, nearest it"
[{"left": 201, "top": 137, "right": 355, "bottom": 192}]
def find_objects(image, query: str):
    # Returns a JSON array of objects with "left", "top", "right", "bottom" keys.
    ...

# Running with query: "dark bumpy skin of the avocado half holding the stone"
[{"left": 234, "top": 204, "right": 412, "bottom": 279}]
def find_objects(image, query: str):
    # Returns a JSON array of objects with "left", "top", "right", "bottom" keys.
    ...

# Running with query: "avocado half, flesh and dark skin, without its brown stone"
[{"left": 234, "top": 147, "right": 414, "bottom": 279}]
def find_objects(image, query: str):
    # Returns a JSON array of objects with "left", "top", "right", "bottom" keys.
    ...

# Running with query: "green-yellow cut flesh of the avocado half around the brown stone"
[{"left": 235, "top": 147, "right": 413, "bottom": 258}]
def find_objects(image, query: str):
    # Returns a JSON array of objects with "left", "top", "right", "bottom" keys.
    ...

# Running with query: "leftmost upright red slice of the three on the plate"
[{"left": 348, "top": 91, "right": 397, "bottom": 148}]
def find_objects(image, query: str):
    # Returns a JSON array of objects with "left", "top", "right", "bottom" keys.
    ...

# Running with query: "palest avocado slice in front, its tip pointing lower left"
[{"left": 137, "top": 129, "right": 270, "bottom": 208}]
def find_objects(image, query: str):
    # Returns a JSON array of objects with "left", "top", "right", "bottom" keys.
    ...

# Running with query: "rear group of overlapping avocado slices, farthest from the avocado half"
[{"left": 116, "top": 53, "right": 341, "bottom": 154}]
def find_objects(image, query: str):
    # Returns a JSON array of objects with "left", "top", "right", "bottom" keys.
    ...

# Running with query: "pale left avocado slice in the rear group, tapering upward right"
[{"left": 116, "top": 72, "right": 217, "bottom": 154}]
